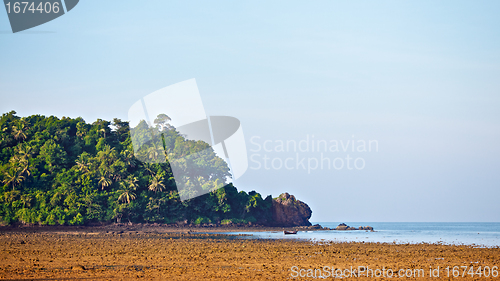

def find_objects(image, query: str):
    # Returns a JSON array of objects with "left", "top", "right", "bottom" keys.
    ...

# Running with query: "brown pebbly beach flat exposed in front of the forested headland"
[{"left": 0, "top": 228, "right": 500, "bottom": 280}]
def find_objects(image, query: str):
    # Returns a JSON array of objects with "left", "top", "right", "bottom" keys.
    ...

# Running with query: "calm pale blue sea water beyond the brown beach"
[{"left": 224, "top": 222, "right": 500, "bottom": 247}]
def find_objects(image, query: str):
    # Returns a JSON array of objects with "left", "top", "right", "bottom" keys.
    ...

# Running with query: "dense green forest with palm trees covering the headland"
[{"left": 0, "top": 111, "right": 272, "bottom": 225}]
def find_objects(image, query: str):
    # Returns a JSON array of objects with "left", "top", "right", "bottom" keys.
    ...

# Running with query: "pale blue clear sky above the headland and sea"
[{"left": 0, "top": 0, "right": 500, "bottom": 222}]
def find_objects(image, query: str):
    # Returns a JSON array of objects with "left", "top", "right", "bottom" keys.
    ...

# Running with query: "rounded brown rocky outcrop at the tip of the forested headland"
[{"left": 272, "top": 193, "right": 312, "bottom": 226}]
